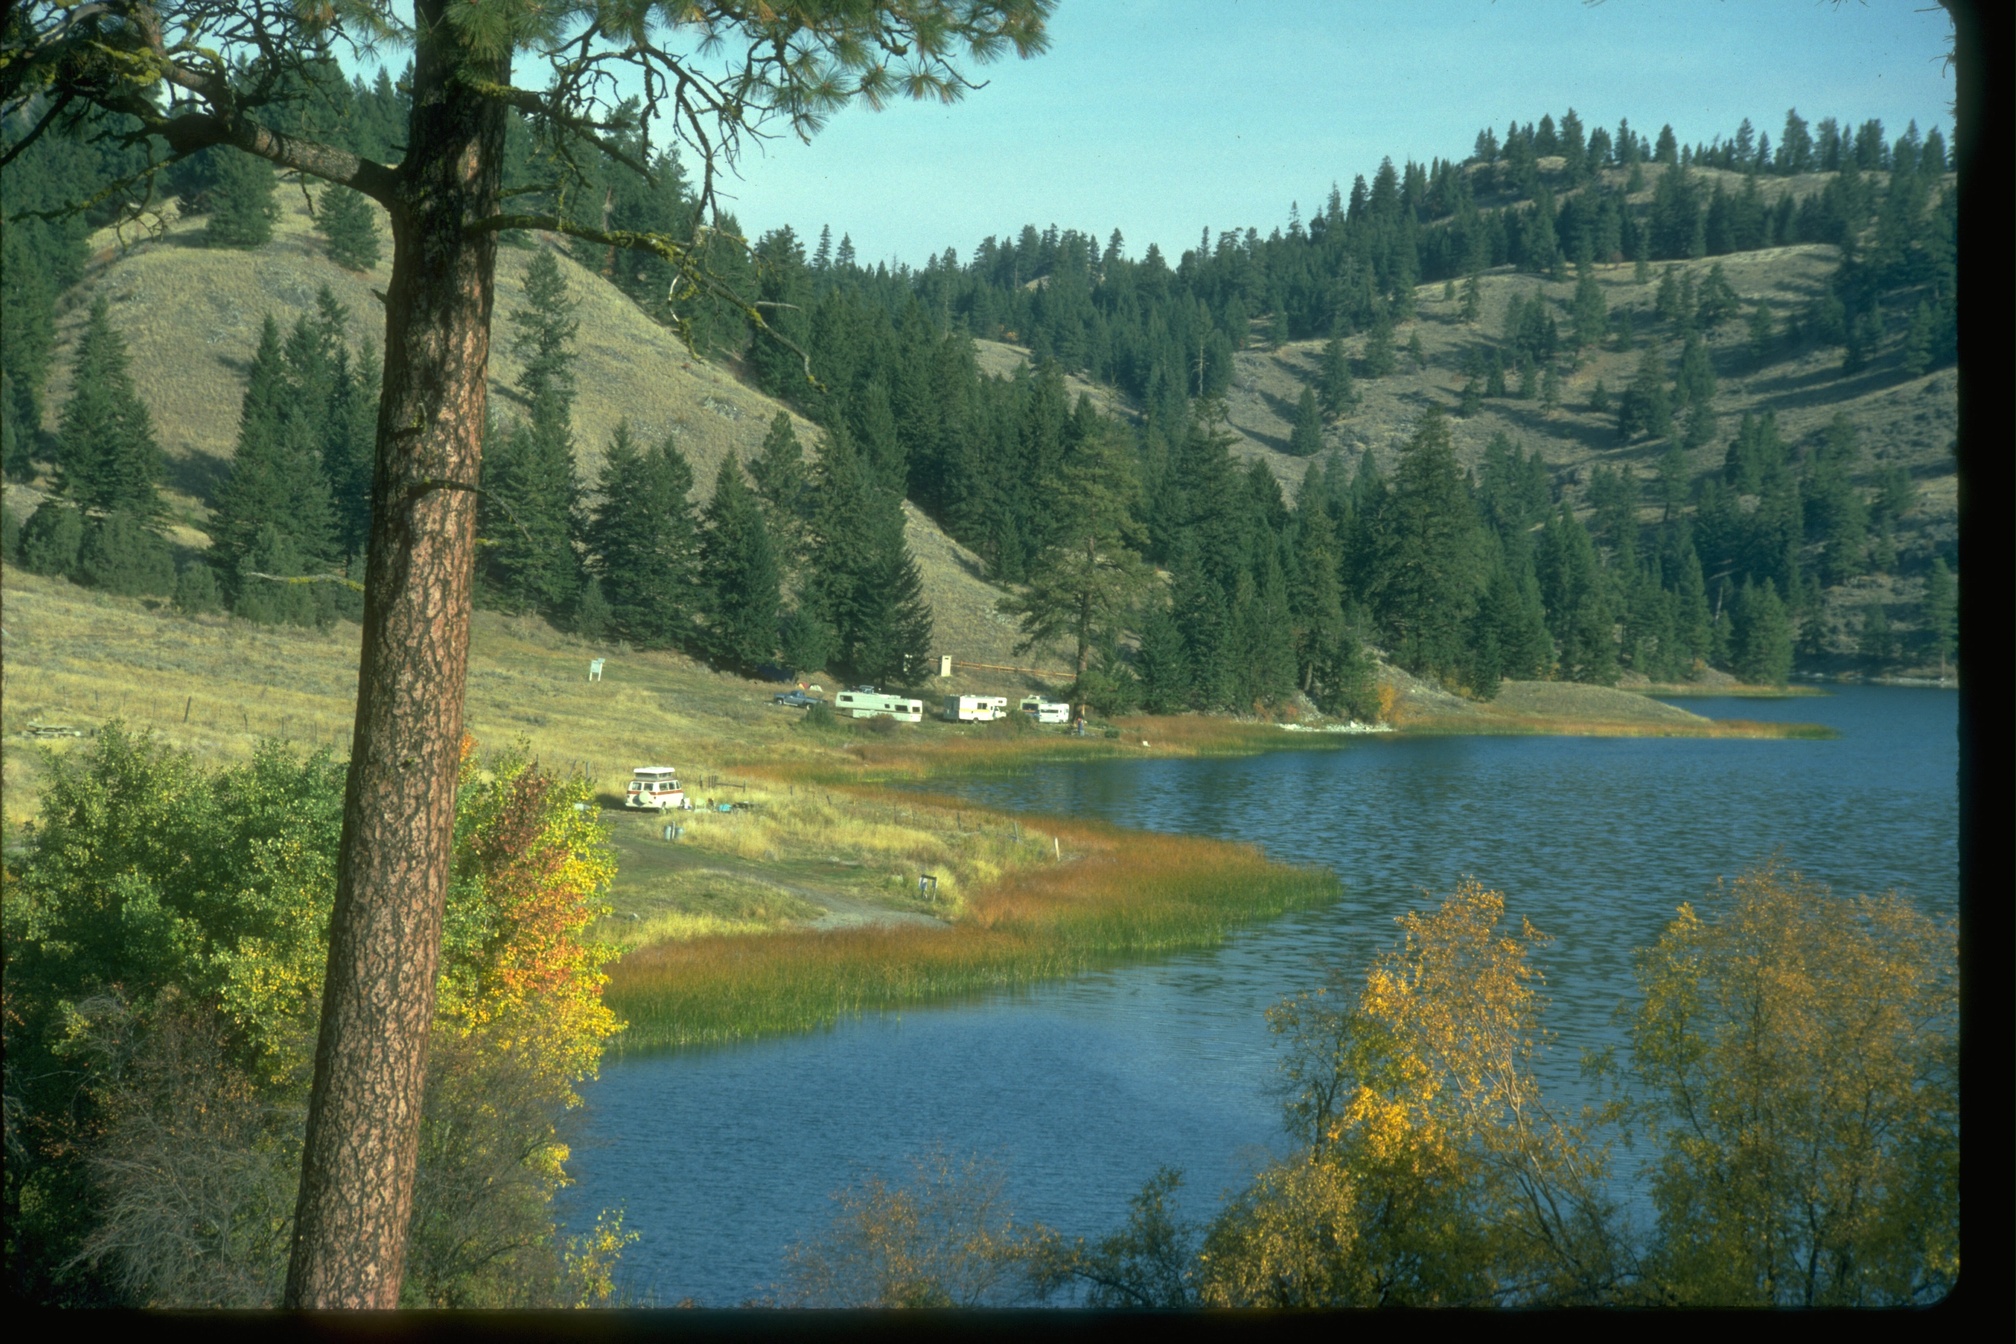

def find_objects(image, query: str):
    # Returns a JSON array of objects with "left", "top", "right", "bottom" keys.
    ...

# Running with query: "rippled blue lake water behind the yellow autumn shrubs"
[{"left": 560, "top": 687, "right": 1960, "bottom": 1306}]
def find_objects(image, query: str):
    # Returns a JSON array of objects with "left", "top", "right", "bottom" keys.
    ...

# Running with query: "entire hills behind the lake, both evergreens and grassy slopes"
[{"left": 4, "top": 77, "right": 1958, "bottom": 715}]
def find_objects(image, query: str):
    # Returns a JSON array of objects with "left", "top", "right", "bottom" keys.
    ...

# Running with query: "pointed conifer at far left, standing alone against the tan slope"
[{"left": 56, "top": 294, "right": 161, "bottom": 522}]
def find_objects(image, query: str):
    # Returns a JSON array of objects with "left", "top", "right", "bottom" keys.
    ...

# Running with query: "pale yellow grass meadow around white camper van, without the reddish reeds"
[{"left": 0, "top": 570, "right": 1088, "bottom": 943}]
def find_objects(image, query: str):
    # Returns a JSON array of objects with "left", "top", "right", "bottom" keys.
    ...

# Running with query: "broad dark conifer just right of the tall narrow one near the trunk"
[{"left": 585, "top": 421, "right": 696, "bottom": 649}]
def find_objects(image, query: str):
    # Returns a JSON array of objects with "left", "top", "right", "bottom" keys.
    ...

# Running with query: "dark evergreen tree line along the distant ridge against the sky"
[{"left": 725, "top": 106, "right": 1956, "bottom": 451}]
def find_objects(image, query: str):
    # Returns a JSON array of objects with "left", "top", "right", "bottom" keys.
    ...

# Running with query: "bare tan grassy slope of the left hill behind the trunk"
[{"left": 23, "top": 191, "right": 1066, "bottom": 669}]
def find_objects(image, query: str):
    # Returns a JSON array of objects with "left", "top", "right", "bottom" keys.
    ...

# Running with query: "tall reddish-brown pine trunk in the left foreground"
[{"left": 286, "top": 0, "right": 508, "bottom": 1308}]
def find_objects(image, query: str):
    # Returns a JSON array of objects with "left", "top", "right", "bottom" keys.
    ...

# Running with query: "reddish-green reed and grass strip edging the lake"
[{"left": 588, "top": 691, "right": 1835, "bottom": 1056}]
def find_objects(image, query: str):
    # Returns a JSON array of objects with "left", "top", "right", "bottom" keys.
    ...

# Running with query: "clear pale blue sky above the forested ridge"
[{"left": 705, "top": 0, "right": 1954, "bottom": 266}]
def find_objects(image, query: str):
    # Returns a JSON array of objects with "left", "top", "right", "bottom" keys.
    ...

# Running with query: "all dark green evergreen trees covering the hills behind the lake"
[{"left": 8, "top": 95, "right": 1954, "bottom": 711}]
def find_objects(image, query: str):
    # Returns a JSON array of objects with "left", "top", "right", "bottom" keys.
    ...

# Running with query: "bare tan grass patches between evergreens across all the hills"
[{"left": 8, "top": 169, "right": 1958, "bottom": 689}]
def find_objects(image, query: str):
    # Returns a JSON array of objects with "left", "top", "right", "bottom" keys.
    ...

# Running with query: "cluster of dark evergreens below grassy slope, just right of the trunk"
[{"left": 478, "top": 252, "right": 931, "bottom": 681}]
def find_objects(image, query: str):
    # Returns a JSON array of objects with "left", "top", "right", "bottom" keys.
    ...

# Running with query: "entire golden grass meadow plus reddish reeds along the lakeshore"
[{"left": 0, "top": 570, "right": 1830, "bottom": 1050}]
